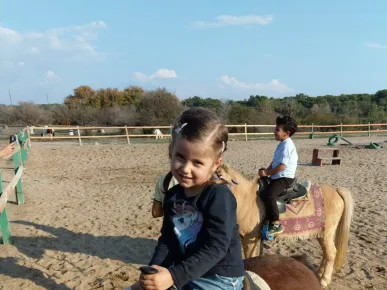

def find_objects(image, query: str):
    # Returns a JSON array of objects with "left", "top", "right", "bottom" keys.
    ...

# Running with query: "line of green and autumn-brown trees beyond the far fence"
[{"left": 0, "top": 86, "right": 387, "bottom": 126}]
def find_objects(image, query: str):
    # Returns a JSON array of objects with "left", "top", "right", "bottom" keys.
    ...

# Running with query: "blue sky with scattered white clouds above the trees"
[{"left": 0, "top": 0, "right": 387, "bottom": 104}]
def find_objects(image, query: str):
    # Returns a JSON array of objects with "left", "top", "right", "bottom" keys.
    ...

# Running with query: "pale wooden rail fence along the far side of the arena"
[{"left": 30, "top": 123, "right": 387, "bottom": 146}]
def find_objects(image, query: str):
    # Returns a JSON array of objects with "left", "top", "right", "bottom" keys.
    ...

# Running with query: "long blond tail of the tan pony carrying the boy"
[{"left": 335, "top": 187, "right": 354, "bottom": 271}]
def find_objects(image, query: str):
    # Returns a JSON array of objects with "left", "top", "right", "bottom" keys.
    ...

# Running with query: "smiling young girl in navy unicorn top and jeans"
[{"left": 132, "top": 108, "right": 244, "bottom": 290}]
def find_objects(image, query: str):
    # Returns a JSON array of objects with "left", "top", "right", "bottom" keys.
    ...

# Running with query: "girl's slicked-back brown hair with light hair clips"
[{"left": 169, "top": 108, "right": 228, "bottom": 157}]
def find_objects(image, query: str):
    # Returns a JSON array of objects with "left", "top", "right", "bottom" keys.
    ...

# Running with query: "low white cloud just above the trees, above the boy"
[{"left": 220, "top": 75, "right": 293, "bottom": 93}]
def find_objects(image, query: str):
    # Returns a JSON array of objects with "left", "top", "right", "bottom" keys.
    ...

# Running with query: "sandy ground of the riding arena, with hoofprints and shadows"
[{"left": 0, "top": 137, "right": 387, "bottom": 290}]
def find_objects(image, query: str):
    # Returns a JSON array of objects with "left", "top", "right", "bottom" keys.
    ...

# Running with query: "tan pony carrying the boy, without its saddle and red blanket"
[{"left": 217, "top": 164, "right": 354, "bottom": 287}]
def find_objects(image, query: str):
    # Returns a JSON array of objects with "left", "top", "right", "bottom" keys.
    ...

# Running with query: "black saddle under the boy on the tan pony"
[{"left": 259, "top": 178, "right": 309, "bottom": 214}]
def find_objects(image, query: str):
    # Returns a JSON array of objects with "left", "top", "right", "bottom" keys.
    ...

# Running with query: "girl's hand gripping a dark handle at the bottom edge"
[{"left": 140, "top": 265, "right": 174, "bottom": 290}]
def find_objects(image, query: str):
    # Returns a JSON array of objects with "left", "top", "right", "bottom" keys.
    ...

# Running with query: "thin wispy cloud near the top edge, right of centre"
[{"left": 192, "top": 15, "right": 274, "bottom": 28}]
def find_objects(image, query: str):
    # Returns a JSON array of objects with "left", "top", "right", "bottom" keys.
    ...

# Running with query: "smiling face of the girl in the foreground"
[{"left": 171, "top": 138, "right": 222, "bottom": 195}]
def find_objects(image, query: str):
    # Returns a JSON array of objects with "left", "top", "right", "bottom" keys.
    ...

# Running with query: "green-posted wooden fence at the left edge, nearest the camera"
[{"left": 0, "top": 128, "right": 31, "bottom": 245}]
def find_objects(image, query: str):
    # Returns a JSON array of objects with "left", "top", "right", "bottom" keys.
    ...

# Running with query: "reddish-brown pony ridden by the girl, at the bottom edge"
[{"left": 126, "top": 255, "right": 322, "bottom": 290}]
